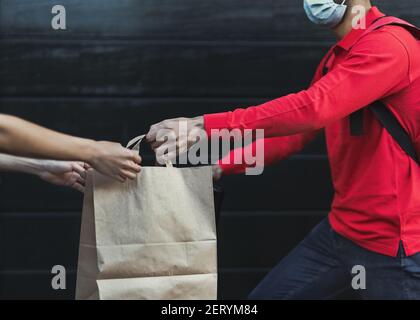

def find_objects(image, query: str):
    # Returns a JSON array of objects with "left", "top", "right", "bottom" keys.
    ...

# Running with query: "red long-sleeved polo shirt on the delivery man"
[{"left": 204, "top": 7, "right": 420, "bottom": 256}]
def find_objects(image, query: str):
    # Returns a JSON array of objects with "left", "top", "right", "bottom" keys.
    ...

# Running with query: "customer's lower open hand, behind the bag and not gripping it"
[{"left": 37, "top": 160, "right": 86, "bottom": 192}]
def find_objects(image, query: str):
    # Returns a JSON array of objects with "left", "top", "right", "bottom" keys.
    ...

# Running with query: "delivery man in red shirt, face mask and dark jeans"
[{"left": 147, "top": 0, "right": 420, "bottom": 299}]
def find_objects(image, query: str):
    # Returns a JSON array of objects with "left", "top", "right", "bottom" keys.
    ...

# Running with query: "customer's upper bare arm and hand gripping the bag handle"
[{"left": 0, "top": 114, "right": 141, "bottom": 181}]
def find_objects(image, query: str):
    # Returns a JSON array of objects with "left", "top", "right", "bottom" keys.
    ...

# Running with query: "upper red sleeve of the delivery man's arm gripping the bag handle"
[{"left": 204, "top": 30, "right": 409, "bottom": 137}]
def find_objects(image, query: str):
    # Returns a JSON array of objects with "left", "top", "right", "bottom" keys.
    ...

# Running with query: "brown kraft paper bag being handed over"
[{"left": 76, "top": 137, "right": 217, "bottom": 300}]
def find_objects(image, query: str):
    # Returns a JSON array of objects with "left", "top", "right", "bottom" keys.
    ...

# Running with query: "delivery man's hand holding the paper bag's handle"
[{"left": 146, "top": 116, "right": 205, "bottom": 163}]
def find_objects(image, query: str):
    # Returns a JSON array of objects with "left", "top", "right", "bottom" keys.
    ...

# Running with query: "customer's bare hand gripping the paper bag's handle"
[{"left": 88, "top": 141, "right": 141, "bottom": 182}]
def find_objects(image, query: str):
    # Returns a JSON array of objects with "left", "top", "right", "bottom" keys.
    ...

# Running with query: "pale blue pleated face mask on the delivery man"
[{"left": 303, "top": 0, "right": 348, "bottom": 28}]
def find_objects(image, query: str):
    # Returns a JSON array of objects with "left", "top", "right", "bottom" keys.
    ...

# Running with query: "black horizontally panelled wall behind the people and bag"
[{"left": 0, "top": 0, "right": 420, "bottom": 299}]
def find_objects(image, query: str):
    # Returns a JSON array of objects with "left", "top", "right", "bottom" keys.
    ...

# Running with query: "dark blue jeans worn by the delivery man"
[{"left": 249, "top": 219, "right": 420, "bottom": 300}]
